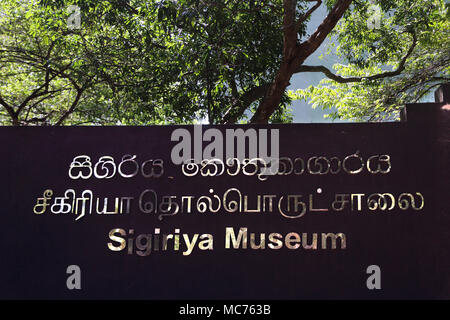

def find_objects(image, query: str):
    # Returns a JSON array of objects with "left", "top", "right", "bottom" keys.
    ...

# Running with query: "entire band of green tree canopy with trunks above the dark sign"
[{"left": 0, "top": 0, "right": 450, "bottom": 125}]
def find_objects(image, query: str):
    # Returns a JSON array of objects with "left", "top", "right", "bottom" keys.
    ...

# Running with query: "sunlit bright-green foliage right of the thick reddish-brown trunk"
[{"left": 291, "top": 1, "right": 450, "bottom": 121}]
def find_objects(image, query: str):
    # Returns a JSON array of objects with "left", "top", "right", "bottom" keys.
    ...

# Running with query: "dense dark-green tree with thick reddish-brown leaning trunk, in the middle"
[{"left": 134, "top": 0, "right": 352, "bottom": 123}]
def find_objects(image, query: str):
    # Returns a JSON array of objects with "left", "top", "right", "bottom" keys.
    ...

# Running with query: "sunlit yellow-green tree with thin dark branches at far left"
[{"left": 0, "top": 1, "right": 96, "bottom": 125}]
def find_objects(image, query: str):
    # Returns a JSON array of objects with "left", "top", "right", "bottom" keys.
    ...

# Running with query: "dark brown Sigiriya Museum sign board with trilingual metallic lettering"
[{"left": 0, "top": 104, "right": 450, "bottom": 299}]
